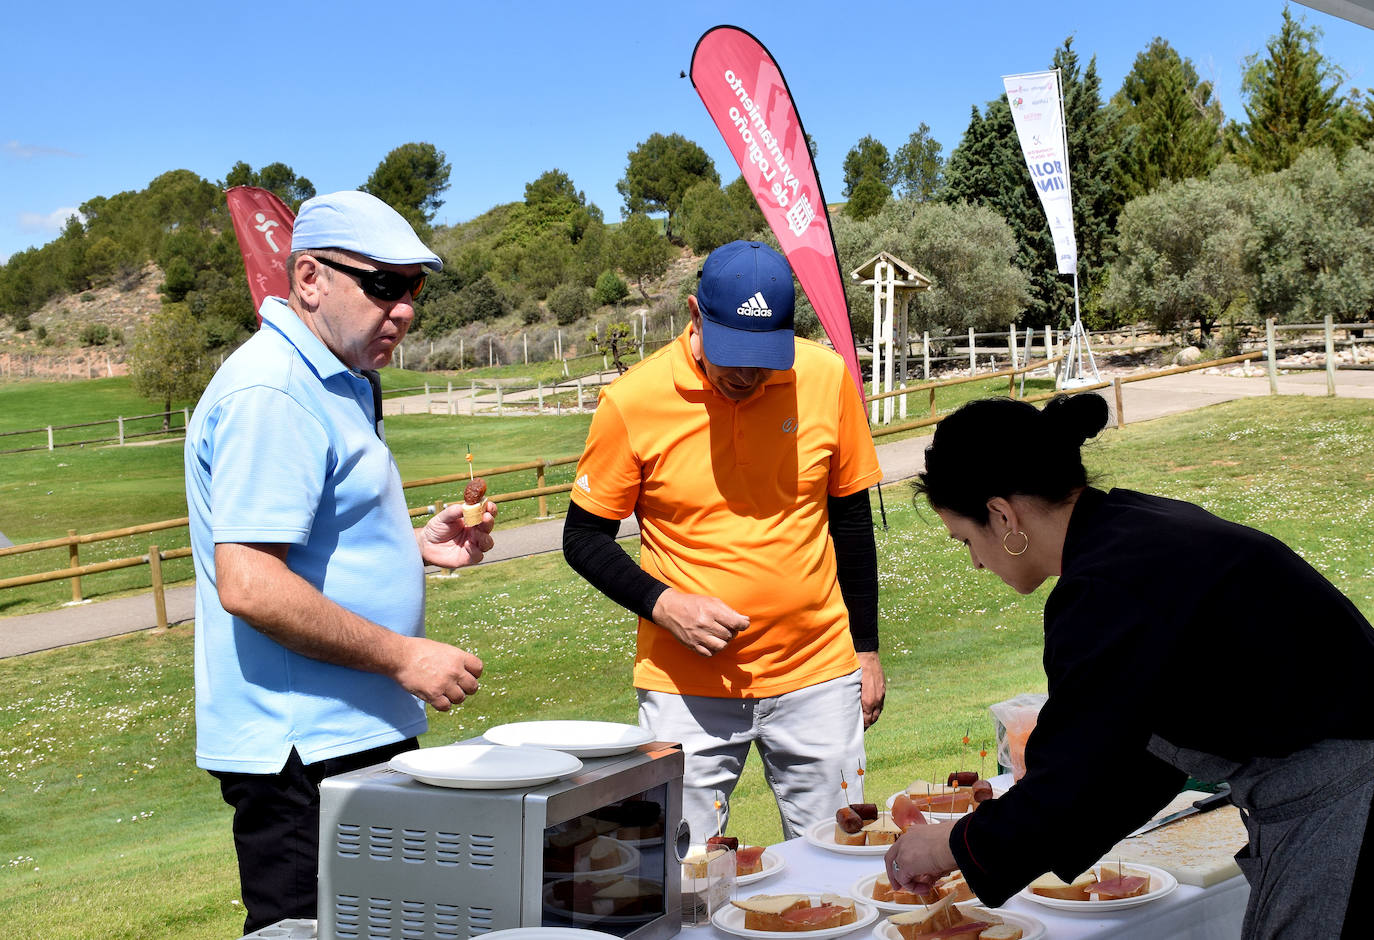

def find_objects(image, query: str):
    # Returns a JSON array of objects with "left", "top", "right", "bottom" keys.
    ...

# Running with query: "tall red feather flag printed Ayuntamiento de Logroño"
[{"left": 691, "top": 26, "right": 863, "bottom": 397}]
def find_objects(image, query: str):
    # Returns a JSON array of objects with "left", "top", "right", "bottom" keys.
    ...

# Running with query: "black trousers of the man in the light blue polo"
[{"left": 210, "top": 738, "right": 419, "bottom": 933}]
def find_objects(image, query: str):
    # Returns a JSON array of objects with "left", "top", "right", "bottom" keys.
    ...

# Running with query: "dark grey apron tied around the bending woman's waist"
[{"left": 1150, "top": 735, "right": 1374, "bottom": 940}]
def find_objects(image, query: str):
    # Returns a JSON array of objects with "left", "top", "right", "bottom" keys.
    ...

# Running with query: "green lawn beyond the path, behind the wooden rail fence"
[{"left": 0, "top": 366, "right": 1033, "bottom": 616}]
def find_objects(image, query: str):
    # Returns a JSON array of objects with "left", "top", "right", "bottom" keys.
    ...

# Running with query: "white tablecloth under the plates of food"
[{"left": 697, "top": 838, "right": 1250, "bottom": 940}]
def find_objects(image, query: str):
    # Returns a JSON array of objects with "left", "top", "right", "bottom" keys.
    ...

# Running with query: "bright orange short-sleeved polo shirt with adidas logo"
[{"left": 572, "top": 327, "right": 882, "bottom": 698}]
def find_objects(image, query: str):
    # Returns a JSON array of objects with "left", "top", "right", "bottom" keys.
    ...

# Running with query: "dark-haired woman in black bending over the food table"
[{"left": 886, "top": 394, "right": 1374, "bottom": 937}]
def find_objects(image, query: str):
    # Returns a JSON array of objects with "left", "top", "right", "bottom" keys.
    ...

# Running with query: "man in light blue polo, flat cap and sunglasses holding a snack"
[{"left": 185, "top": 192, "right": 496, "bottom": 933}]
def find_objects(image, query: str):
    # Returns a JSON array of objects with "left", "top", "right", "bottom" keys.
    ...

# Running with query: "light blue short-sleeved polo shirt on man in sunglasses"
[{"left": 185, "top": 297, "right": 426, "bottom": 774}]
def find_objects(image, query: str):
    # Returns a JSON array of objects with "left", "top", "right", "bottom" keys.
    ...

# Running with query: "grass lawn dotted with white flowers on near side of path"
[{"left": 0, "top": 397, "right": 1374, "bottom": 940}]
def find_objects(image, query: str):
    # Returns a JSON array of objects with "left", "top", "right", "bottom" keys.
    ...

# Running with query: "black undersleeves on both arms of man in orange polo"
[{"left": 563, "top": 491, "right": 878, "bottom": 653}]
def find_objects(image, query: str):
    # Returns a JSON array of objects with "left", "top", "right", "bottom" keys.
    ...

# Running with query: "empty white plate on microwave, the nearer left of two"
[{"left": 387, "top": 745, "right": 583, "bottom": 790}]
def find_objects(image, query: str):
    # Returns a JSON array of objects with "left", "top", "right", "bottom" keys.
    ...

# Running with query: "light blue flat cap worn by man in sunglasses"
[{"left": 291, "top": 190, "right": 444, "bottom": 271}]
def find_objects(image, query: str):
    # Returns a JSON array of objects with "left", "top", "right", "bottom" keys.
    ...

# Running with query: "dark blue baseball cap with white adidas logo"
[{"left": 697, "top": 242, "right": 797, "bottom": 370}]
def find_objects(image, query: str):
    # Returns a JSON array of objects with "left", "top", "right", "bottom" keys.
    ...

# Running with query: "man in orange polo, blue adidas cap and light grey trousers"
[{"left": 563, "top": 242, "right": 886, "bottom": 841}]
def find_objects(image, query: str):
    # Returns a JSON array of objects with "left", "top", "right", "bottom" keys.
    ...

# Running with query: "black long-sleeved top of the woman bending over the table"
[{"left": 949, "top": 488, "right": 1374, "bottom": 906}]
